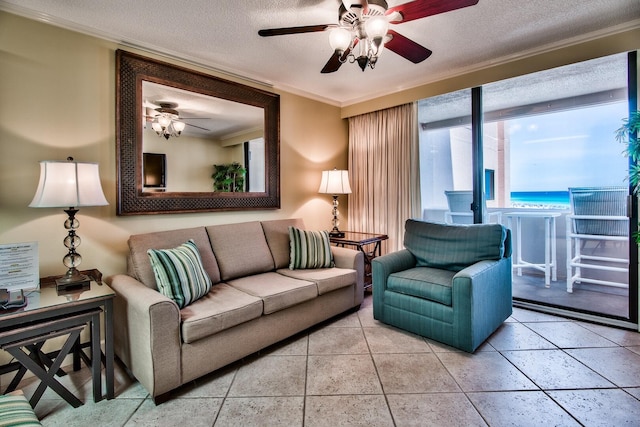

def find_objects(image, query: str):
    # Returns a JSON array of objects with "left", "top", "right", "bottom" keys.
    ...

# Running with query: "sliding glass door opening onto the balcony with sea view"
[{"left": 419, "top": 54, "right": 637, "bottom": 323}]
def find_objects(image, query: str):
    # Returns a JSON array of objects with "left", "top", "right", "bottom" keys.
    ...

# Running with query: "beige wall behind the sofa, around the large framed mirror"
[{"left": 0, "top": 12, "right": 348, "bottom": 276}]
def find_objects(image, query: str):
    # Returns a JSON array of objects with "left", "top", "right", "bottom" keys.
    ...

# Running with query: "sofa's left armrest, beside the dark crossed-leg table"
[{"left": 106, "top": 274, "right": 181, "bottom": 397}]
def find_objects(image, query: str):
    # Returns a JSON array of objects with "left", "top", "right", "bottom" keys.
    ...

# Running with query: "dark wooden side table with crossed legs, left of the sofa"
[{"left": 0, "top": 270, "right": 115, "bottom": 406}]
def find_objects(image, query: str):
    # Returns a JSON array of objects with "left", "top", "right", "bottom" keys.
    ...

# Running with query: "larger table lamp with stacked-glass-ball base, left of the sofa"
[{"left": 29, "top": 157, "right": 109, "bottom": 290}]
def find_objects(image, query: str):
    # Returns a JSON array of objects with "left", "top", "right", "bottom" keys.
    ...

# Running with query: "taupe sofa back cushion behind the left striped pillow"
[{"left": 127, "top": 227, "right": 220, "bottom": 289}]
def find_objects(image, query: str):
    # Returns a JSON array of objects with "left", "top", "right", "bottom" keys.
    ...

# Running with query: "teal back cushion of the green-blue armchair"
[{"left": 404, "top": 219, "right": 507, "bottom": 271}]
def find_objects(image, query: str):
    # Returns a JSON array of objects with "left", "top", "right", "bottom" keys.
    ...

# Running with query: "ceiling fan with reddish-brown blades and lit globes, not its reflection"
[{"left": 258, "top": 0, "right": 479, "bottom": 73}]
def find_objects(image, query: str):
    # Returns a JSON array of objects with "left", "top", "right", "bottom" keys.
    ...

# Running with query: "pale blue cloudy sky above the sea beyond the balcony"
[{"left": 506, "top": 102, "right": 628, "bottom": 191}]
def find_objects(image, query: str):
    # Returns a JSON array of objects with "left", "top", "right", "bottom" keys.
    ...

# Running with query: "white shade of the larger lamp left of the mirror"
[{"left": 29, "top": 160, "right": 109, "bottom": 208}]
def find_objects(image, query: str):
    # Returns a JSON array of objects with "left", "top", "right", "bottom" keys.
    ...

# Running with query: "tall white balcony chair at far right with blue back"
[{"left": 567, "top": 187, "right": 629, "bottom": 292}]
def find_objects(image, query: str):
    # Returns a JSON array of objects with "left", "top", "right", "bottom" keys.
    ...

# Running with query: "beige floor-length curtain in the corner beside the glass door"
[{"left": 348, "top": 103, "right": 421, "bottom": 253}]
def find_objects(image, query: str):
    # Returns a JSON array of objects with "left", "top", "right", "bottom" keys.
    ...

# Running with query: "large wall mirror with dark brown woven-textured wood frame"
[{"left": 116, "top": 50, "right": 280, "bottom": 215}]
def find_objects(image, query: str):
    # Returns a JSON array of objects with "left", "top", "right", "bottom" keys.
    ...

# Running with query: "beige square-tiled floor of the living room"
[{"left": 11, "top": 294, "right": 640, "bottom": 427}]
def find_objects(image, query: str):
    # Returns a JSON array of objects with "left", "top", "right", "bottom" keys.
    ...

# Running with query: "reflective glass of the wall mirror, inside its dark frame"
[{"left": 142, "top": 80, "right": 265, "bottom": 193}]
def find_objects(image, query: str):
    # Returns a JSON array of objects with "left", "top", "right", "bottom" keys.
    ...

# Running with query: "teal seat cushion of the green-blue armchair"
[{"left": 387, "top": 267, "right": 456, "bottom": 306}]
